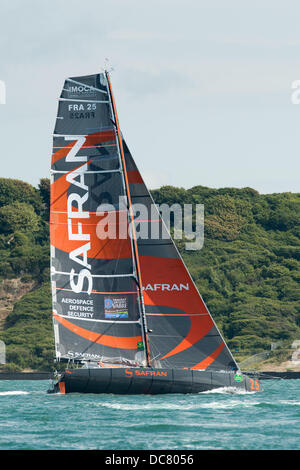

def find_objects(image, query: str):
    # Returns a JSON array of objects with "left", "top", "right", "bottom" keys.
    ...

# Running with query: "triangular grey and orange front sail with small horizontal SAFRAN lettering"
[{"left": 123, "top": 141, "right": 238, "bottom": 370}]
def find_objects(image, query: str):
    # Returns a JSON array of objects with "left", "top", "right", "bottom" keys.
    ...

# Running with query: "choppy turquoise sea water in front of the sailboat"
[{"left": 0, "top": 379, "right": 300, "bottom": 450}]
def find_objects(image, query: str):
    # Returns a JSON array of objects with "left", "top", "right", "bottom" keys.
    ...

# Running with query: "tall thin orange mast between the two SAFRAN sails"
[{"left": 105, "top": 70, "right": 151, "bottom": 367}]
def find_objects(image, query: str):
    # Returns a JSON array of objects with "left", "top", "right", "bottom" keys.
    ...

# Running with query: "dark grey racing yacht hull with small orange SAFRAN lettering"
[{"left": 48, "top": 368, "right": 261, "bottom": 395}]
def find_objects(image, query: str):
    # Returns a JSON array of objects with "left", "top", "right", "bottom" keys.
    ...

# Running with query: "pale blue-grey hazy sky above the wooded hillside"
[{"left": 0, "top": 0, "right": 300, "bottom": 194}]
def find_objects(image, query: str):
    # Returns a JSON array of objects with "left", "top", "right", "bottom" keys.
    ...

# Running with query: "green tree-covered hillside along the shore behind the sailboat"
[{"left": 0, "top": 178, "right": 300, "bottom": 373}]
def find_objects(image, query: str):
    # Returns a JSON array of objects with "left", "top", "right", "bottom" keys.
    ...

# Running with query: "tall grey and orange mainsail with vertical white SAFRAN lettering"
[{"left": 50, "top": 74, "right": 145, "bottom": 365}]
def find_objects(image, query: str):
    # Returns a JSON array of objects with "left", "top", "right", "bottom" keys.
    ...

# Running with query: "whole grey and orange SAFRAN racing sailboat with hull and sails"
[{"left": 48, "top": 70, "right": 260, "bottom": 394}]
